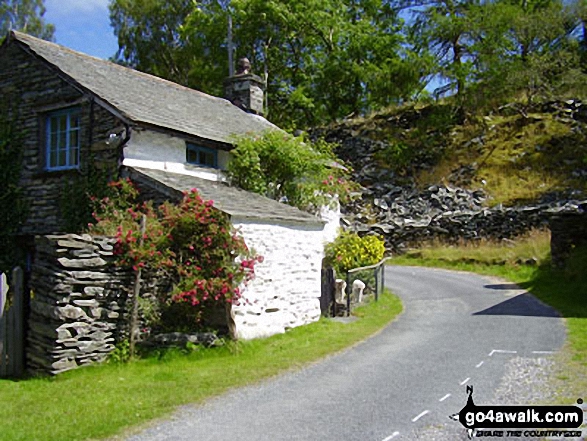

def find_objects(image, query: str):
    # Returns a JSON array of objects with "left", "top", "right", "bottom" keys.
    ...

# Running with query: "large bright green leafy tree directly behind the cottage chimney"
[{"left": 110, "top": 0, "right": 422, "bottom": 128}]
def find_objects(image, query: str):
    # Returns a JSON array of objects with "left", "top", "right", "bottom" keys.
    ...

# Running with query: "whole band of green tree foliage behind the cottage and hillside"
[{"left": 111, "top": 0, "right": 587, "bottom": 125}]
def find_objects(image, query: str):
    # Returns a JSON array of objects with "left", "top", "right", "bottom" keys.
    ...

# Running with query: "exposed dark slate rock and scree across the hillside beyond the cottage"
[{"left": 310, "top": 100, "right": 587, "bottom": 252}]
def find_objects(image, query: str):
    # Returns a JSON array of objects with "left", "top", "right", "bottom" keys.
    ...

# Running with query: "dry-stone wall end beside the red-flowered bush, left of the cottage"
[{"left": 27, "top": 234, "right": 131, "bottom": 374}]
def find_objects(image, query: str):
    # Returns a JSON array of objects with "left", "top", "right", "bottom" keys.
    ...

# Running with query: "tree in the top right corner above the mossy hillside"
[{"left": 472, "top": 0, "right": 579, "bottom": 104}]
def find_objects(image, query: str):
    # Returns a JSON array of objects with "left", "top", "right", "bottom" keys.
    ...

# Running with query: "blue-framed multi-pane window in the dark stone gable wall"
[{"left": 45, "top": 108, "right": 81, "bottom": 170}]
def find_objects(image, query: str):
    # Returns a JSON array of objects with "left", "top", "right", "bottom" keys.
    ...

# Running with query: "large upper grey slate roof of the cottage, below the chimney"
[{"left": 8, "top": 31, "right": 277, "bottom": 143}]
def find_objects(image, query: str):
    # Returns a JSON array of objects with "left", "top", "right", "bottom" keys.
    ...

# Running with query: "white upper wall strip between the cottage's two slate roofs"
[{"left": 123, "top": 130, "right": 230, "bottom": 181}]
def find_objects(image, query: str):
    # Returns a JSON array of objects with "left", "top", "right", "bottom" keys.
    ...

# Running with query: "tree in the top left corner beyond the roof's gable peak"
[{"left": 0, "top": 0, "right": 55, "bottom": 41}]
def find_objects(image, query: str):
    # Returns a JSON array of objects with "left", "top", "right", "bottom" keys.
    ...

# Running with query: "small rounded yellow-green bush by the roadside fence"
[{"left": 326, "top": 232, "right": 385, "bottom": 275}]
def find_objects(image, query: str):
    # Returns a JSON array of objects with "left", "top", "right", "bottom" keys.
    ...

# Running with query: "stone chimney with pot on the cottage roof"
[{"left": 224, "top": 58, "right": 265, "bottom": 115}]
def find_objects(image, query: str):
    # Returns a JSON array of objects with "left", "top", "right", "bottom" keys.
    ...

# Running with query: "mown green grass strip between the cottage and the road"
[{"left": 0, "top": 294, "right": 402, "bottom": 441}]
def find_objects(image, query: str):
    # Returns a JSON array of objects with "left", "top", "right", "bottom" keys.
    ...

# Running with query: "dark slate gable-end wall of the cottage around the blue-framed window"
[{"left": 0, "top": 43, "right": 124, "bottom": 235}]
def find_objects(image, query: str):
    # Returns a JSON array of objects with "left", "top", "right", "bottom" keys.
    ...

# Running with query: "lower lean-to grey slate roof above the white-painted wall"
[{"left": 126, "top": 167, "right": 325, "bottom": 225}]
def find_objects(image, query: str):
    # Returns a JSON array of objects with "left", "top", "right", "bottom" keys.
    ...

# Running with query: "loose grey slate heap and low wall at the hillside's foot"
[{"left": 343, "top": 185, "right": 587, "bottom": 253}]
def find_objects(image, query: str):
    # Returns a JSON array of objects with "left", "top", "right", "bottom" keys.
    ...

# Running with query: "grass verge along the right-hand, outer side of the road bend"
[{"left": 392, "top": 232, "right": 587, "bottom": 403}]
